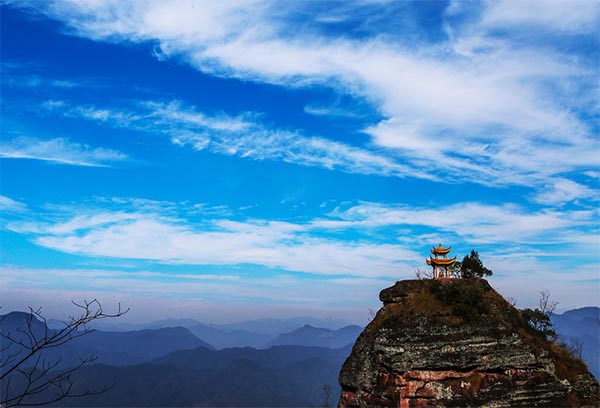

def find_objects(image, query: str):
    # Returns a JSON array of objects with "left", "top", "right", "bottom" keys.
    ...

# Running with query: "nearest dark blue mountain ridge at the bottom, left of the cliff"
[{"left": 58, "top": 346, "right": 351, "bottom": 407}]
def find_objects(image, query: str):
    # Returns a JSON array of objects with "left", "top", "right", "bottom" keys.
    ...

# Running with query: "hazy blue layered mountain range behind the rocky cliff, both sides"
[{"left": 0, "top": 307, "right": 600, "bottom": 407}]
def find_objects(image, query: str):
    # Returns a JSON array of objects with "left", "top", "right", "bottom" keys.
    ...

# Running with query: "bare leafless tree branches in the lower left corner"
[{"left": 0, "top": 299, "right": 129, "bottom": 408}]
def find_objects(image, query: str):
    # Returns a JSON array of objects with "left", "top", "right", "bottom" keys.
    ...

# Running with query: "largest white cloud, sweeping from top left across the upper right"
[{"left": 17, "top": 0, "right": 600, "bottom": 191}]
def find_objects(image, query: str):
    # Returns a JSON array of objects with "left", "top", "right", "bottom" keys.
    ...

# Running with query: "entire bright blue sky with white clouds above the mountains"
[{"left": 0, "top": 0, "right": 600, "bottom": 323}]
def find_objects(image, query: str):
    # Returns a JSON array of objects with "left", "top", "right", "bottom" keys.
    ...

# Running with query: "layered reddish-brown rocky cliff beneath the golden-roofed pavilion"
[{"left": 339, "top": 279, "right": 600, "bottom": 408}]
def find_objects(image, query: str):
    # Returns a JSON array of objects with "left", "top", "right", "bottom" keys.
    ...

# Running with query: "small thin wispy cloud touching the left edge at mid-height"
[{"left": 0, "top": 137, "right": 127, "bottom": 167}]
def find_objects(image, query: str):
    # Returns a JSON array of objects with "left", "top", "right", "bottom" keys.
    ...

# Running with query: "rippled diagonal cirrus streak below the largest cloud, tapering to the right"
[{"left": 42, "top": 100, "right": 426, "bottom": 179}]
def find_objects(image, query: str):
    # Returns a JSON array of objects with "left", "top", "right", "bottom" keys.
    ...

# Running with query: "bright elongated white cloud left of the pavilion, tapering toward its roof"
[{"left": 8, "top": 204, "right": 418, "bottom": 276}]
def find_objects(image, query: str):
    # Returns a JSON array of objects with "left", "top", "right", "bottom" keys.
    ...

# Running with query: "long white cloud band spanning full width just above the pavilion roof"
[{"left": 8, "top": 200, "right": 598, "bottom": 277}]
